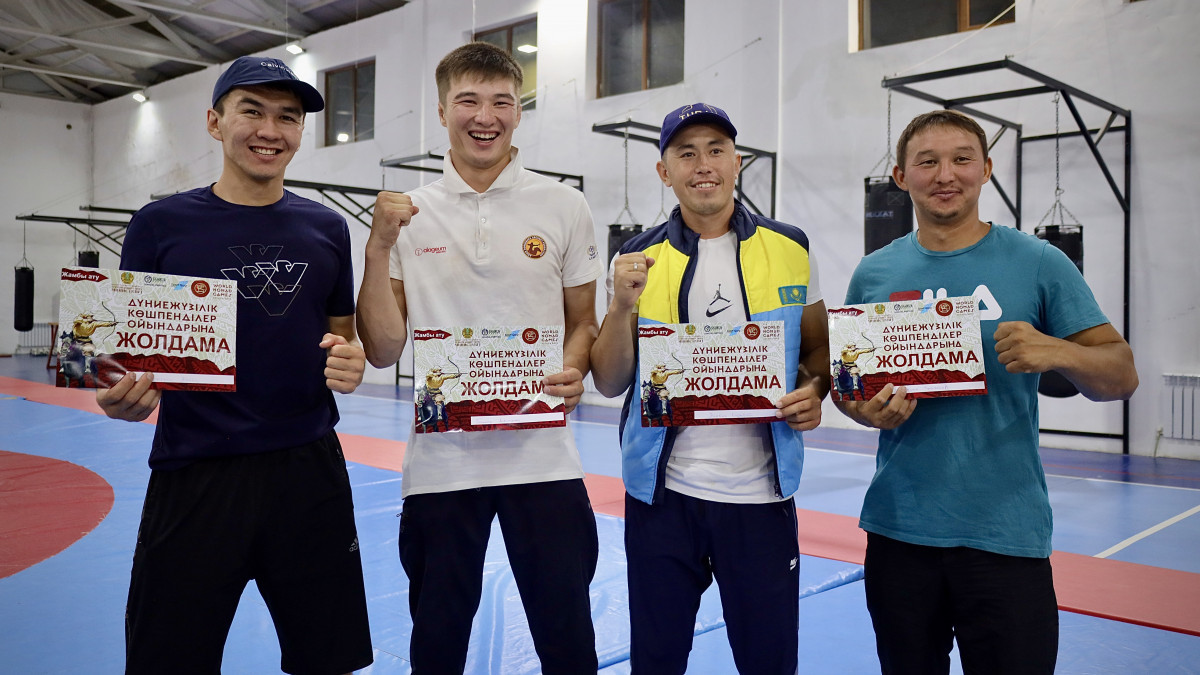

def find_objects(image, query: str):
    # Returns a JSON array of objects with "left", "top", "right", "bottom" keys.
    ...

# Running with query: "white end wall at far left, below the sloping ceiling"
[{"left": 0, "top": 94, "right": 92, "bottom": 354}]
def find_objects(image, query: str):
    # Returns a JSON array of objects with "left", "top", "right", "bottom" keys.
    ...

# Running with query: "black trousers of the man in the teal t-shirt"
[{"left": 865, "top": 533, "right": 1058, "bottom": 675}]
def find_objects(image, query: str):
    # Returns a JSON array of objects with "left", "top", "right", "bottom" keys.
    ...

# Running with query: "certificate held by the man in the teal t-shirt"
[{"left": 828, "top": 295, "right": 988, "bottom": 401}]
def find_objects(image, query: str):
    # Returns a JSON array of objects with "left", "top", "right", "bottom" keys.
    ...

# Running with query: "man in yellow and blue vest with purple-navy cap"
[{"left": 592, "top": 103, "right": 829, "bottom": 675}]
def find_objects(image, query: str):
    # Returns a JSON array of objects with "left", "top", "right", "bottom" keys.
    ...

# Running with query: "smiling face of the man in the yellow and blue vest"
[{"left": 658, "top": 124, "right": 742, "bottom": 230}]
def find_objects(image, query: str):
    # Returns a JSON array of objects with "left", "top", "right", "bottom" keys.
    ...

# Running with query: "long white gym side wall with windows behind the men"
[{"left": 18, "top": 0, "right": 1200, "bottom": 459}]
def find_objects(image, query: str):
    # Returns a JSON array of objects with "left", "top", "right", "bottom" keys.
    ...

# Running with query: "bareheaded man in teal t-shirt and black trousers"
[{"left": 836, "top": 110, "right": 1138, "bottom": 674}]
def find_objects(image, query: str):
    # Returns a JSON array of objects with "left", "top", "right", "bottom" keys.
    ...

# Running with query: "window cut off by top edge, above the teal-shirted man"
[{"left": 858, "top": 0, "right": 1016, "bottom": 49}]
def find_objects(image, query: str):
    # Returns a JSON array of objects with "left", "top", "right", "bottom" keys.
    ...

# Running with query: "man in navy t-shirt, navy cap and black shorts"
[{"left": 96, "top": 56, "right": 373, "bottom": 675}]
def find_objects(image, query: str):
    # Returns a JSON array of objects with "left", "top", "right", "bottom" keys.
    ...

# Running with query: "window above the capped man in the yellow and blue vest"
[{"left": 596, "top": 0, "right": 684, "bottom": 97}]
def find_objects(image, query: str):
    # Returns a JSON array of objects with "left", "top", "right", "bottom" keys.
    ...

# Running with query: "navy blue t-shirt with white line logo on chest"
[{"left": 121, "top": 187, "right": 354, "bottom": 470}]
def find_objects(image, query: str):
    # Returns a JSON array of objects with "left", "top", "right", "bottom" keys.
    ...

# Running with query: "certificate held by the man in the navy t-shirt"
[{"left": 54, "top": 268, "right": 238, "bottom": 392}]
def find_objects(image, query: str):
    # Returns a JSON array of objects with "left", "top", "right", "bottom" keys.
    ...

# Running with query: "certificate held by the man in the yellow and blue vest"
[{"left": 637, "top": 321, "right": 787, "bottom": 426}]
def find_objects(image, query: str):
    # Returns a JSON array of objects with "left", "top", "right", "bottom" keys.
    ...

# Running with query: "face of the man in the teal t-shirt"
[{"left": 893, "top": 125, "right": 991, "bottom": 226}]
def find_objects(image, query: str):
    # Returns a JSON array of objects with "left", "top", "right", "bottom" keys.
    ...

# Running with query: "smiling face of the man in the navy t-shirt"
[{"left": 208, "top": 86, "right": 304, "bottom": 196}]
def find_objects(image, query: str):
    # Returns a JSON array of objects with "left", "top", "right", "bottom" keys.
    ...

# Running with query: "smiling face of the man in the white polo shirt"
[{"left": 438, "top": 73, "right": 521, "bottom": 192}]
